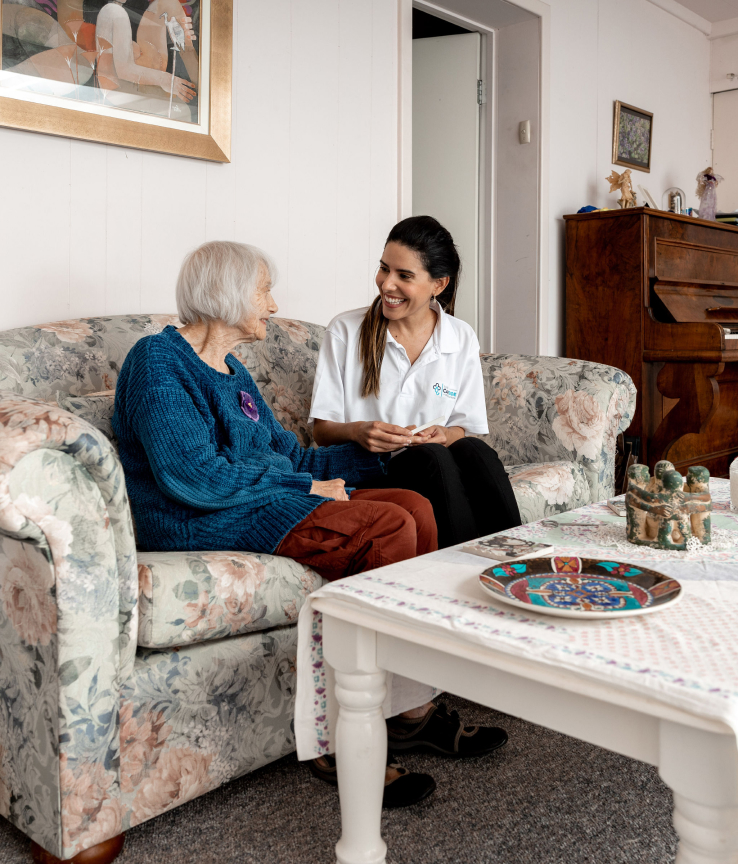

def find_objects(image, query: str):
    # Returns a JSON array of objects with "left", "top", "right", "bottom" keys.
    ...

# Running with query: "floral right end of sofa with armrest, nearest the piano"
[{"left": 479, "top": 354, "right": 636, "bottom": 501}]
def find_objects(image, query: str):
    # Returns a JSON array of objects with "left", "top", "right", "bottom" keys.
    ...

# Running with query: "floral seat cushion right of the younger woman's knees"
[{"left": 505, "top": 460, "right": 590, "bottom": 522}]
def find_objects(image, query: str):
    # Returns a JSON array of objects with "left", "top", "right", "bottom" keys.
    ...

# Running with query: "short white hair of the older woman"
[{"left": 177, "top": 240, "right": 277, "bottom": 327}]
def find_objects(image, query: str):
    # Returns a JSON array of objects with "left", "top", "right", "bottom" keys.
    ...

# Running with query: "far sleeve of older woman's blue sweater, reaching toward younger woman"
[{"left": 254, "top": 385, "right": 386, "bottom": 486}]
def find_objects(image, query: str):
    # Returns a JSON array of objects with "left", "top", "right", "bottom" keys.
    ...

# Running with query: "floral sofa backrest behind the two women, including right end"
[{"left": 0, "top": 315, "right": 636, "bottom": 501}]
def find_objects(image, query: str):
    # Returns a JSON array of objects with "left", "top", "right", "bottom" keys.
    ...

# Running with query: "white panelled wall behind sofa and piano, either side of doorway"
[{"left": 0, "top": 0, "right": 710, "bottom": 354}]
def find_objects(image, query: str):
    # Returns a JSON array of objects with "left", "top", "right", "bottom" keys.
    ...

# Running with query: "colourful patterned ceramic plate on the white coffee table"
[{"left": 479, "top": 556, "right": 682, "bottom": 618}]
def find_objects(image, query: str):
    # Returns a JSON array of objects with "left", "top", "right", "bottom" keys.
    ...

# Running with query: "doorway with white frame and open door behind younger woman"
[{"left": 399, "top": 0, "right": 550, "bottom": 354}]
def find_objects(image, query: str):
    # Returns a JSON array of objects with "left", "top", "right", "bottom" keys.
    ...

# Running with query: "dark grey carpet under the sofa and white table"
[{"left": 0, "top": 696, "right": 676, "bottom": 864}]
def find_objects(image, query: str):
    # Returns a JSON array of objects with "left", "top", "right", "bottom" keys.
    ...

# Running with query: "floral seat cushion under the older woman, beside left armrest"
[{"left": 138, "top": 552, "right": 323, "bottom": 648}]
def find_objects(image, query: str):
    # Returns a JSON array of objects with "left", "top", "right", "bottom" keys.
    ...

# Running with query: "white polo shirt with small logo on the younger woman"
[{"left": 310, "top": 301, "right": 489, "bottom": 434}]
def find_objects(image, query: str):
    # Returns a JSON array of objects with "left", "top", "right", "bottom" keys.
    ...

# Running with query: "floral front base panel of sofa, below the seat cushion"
[{"left": 120, "top": 626, "right": 297, "bottom": 830}]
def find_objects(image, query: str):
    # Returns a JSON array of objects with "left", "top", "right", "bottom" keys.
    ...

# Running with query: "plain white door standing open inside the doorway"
[{"left": 413, "top": 33, "right": 481, "bottom": 331}]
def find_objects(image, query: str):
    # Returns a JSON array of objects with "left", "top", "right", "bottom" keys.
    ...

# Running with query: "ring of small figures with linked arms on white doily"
[{"left": 625, "top": 460, "right": 712, "bottom": 549}]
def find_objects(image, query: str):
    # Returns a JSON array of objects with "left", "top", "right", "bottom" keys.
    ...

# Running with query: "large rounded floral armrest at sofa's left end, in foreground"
[{"left": 0, "top": 393, "right": 138, "bottom": 859}]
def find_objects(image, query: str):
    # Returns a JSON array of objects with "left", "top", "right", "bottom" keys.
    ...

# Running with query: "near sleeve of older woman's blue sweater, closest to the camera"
[{"left": 131, "top": 386, "right": 313, "bottom": 510}]
